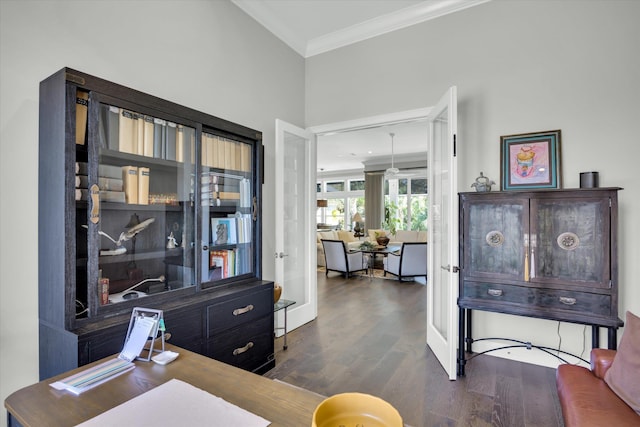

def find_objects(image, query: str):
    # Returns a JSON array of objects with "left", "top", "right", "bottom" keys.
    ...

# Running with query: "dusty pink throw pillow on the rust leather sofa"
[{"left": 604, "top": 311, "right": 640, "bottom": 415}]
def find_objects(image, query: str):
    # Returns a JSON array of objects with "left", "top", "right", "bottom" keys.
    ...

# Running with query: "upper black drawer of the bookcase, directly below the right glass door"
[{"left": 207, "top": 288, "right": 273, "bottom": 338}]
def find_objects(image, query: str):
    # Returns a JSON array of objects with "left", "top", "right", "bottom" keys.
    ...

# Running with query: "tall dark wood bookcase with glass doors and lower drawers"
[{"left": 38, "top": 68, "right": 273, "bottom": 378}]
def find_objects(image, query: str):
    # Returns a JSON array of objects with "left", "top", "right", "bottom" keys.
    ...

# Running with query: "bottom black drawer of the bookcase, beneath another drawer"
[{"left": 207, "top": 316, "right": 273, "bottom": 371}]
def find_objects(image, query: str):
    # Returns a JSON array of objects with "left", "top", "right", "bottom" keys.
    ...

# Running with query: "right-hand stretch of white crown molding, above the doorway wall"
[{"left": 304, "top": 0, "right": 491, "bottom": 58}]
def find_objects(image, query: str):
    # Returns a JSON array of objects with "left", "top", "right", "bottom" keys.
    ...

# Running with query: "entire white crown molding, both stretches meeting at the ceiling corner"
[{"left": 231, "top": 0, "right": 491, "bottom": 58}]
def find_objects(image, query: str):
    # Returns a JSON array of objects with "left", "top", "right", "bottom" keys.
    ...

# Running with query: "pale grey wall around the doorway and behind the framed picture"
[{"left": 306, "top": 0, "right": 640, "bottom": 366}]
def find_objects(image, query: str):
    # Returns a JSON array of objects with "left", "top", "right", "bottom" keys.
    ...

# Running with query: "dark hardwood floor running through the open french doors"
[{"left": 265, "top": 272, "right": 563, "bottom": 427}]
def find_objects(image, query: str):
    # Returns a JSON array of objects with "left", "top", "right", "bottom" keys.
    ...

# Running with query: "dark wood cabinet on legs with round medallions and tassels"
[{"left": 458, "top": 188, "right": 622, "bottom": 376}]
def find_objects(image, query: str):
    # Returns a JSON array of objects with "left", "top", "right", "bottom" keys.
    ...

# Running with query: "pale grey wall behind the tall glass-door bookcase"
[{"left": 0, "top": 0, "right": 304, "bottom": 423}]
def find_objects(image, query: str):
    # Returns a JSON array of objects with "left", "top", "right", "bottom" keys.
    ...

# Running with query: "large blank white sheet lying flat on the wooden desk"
[{"left": 79, "top": 379, "right": 271, "bottom": 427}]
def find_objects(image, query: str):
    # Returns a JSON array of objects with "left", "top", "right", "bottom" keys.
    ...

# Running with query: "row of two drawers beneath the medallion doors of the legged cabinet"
[{"left": 461, "top": 282, "right": 611, "bottom": 317}]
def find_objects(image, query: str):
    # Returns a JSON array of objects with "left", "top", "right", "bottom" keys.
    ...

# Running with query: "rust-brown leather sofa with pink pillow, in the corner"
[{"left": 556, "top": 312, "right": 640, "bottom": 427}]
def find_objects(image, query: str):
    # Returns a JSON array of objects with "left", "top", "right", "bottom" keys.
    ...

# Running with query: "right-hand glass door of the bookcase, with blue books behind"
[{"left": 200, "top": 130, "right": 255, "bottom": 287}]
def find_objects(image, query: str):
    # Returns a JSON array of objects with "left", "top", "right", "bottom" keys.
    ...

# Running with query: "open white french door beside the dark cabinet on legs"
[{"left": 427, "top": 86, "right": 458, "bottom": 380}]
